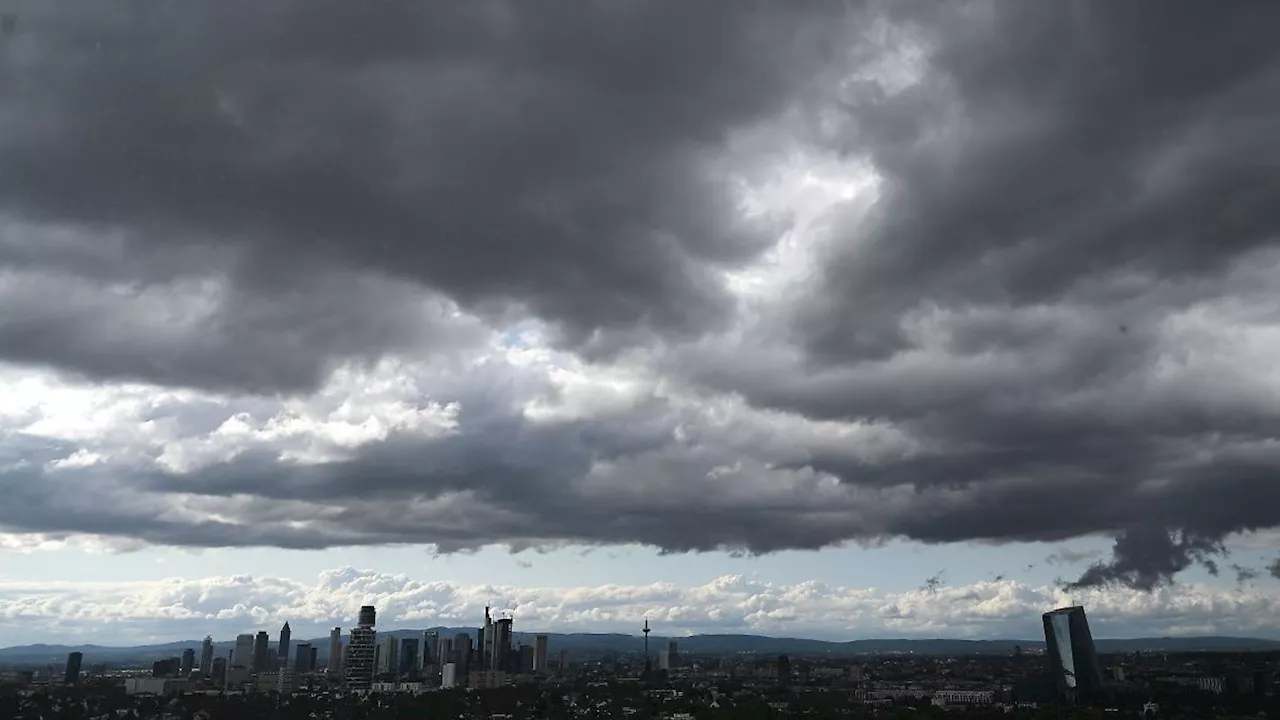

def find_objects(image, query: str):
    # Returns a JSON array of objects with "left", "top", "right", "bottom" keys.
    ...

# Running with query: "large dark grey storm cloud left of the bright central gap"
[{"left": 0, "top": 0, "right": 844, "bottom": 391}]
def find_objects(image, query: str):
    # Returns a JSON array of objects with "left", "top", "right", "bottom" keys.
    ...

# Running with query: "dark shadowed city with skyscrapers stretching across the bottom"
[{"left": 0, "top": 606, "right": 1280, "bottom": 720}]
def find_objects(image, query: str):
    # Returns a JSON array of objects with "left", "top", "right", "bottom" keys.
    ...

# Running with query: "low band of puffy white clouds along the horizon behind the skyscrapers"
[{"left": 0, "top": 568, "right": 1277, "bottom": 644}]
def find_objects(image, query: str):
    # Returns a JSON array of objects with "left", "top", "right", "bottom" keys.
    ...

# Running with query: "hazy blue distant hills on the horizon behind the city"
[{"left": 0, "top": 628, "right": 1280, "bottom": 666}]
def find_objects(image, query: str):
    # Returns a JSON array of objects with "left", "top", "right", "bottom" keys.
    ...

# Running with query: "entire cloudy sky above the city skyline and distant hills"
[{"left": 0, "top": 0, "right": 1280, "bottom": 646}]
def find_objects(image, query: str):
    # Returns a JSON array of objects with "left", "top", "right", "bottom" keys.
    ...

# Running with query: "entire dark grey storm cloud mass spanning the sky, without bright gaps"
[{"left": 0, "top": 1, "right": 1280, "bottom": 589}]
